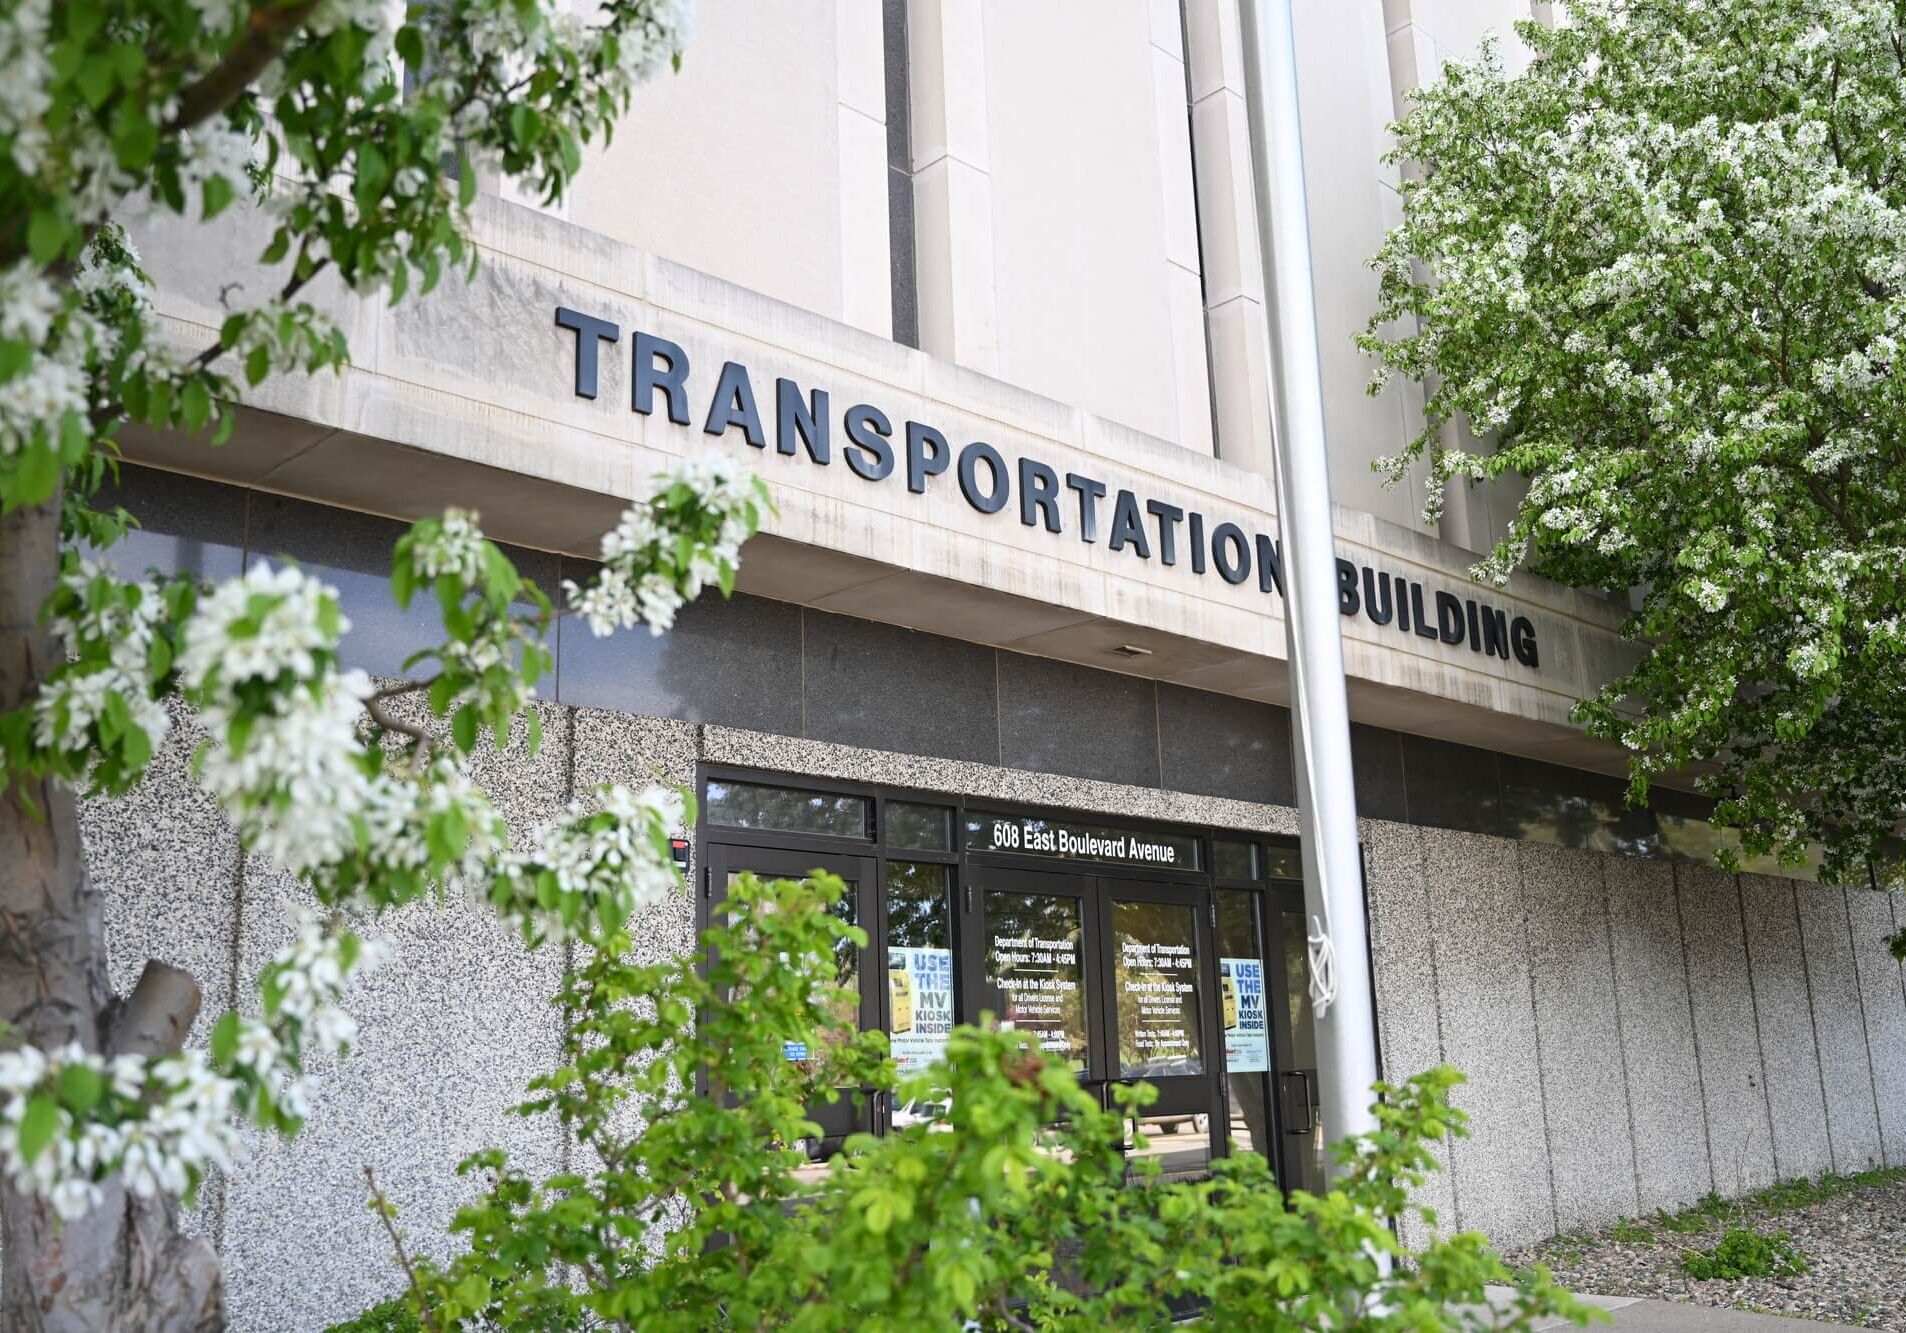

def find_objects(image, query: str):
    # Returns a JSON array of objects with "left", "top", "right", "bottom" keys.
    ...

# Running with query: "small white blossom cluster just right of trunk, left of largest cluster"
[{"left": 34, "top": 561, "right": 172, "bottom": 766}]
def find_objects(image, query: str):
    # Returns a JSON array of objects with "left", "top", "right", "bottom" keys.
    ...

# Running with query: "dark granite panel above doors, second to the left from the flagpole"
[{"left": 999, "top": 652, "right": 1158, "bottom": 799}]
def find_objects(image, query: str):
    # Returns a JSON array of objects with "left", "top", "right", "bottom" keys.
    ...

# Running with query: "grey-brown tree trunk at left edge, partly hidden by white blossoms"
[{"left": 0, "top": 496, "right": 225, "bottom": 1333}]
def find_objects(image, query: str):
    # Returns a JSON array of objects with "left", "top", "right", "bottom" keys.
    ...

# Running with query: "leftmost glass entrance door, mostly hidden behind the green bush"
[{"left": 703, "top": 843, "right": 881, "bottom": 1156}]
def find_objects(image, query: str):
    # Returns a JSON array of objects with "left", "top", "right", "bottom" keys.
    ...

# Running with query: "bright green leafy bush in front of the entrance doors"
[{"left": 374, "top": 877, "right": 1588, "bottom": 1333}]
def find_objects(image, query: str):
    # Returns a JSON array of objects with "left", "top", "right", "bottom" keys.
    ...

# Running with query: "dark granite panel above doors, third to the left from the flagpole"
[{"left": 801, "top": 610, "right": 999, "bottom": 763}]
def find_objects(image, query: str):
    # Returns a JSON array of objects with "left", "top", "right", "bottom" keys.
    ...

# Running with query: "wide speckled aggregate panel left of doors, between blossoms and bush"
[{"left": 223, "top": 698, "right": 570, "bottom": 1333}]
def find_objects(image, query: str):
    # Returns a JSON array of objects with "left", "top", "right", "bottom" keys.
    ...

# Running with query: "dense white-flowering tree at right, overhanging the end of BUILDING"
[{"left": 1363, "top": 0, "right": 1906, "bottom": 952}]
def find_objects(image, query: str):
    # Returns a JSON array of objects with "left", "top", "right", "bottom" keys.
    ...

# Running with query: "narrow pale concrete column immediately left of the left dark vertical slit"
[{"left": 835, "top": 0, "right": 894, "bottom": 338}]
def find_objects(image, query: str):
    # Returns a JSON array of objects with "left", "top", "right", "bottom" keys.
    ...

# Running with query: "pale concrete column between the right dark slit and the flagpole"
[{"left": 1184, "top": 0, "right": 1271, "bottom": 477}]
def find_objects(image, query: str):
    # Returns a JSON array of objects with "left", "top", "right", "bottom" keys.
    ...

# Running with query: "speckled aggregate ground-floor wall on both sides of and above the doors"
[{"left": 86, "top": 694, "right": 1906, "bottom": 1329}]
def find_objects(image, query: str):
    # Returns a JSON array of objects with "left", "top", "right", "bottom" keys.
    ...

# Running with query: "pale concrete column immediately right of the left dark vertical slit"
[{"left": 907, "top": 0, "right": 999, "bottom": 374}]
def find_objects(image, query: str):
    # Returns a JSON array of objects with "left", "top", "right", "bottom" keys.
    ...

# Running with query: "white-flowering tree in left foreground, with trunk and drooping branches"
[{"left": 0, "top": 0, "right": 728, "bottom": 1329}]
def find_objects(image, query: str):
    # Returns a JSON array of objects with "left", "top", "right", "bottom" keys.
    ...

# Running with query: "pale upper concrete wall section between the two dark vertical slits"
[{"left": 907, "top": 0, "right": 1212, "bottom": 454}]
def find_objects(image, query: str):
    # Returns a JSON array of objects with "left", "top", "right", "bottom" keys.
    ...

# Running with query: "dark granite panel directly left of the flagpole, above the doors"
[{"left": 1159, "top": 683, "right": 1296, "bottom": 805}]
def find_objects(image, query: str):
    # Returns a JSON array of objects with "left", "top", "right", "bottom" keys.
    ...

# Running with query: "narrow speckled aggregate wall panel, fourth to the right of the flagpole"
[{"left": 1603, "top": 856, "right": 1713, "bottom": 1213}]
